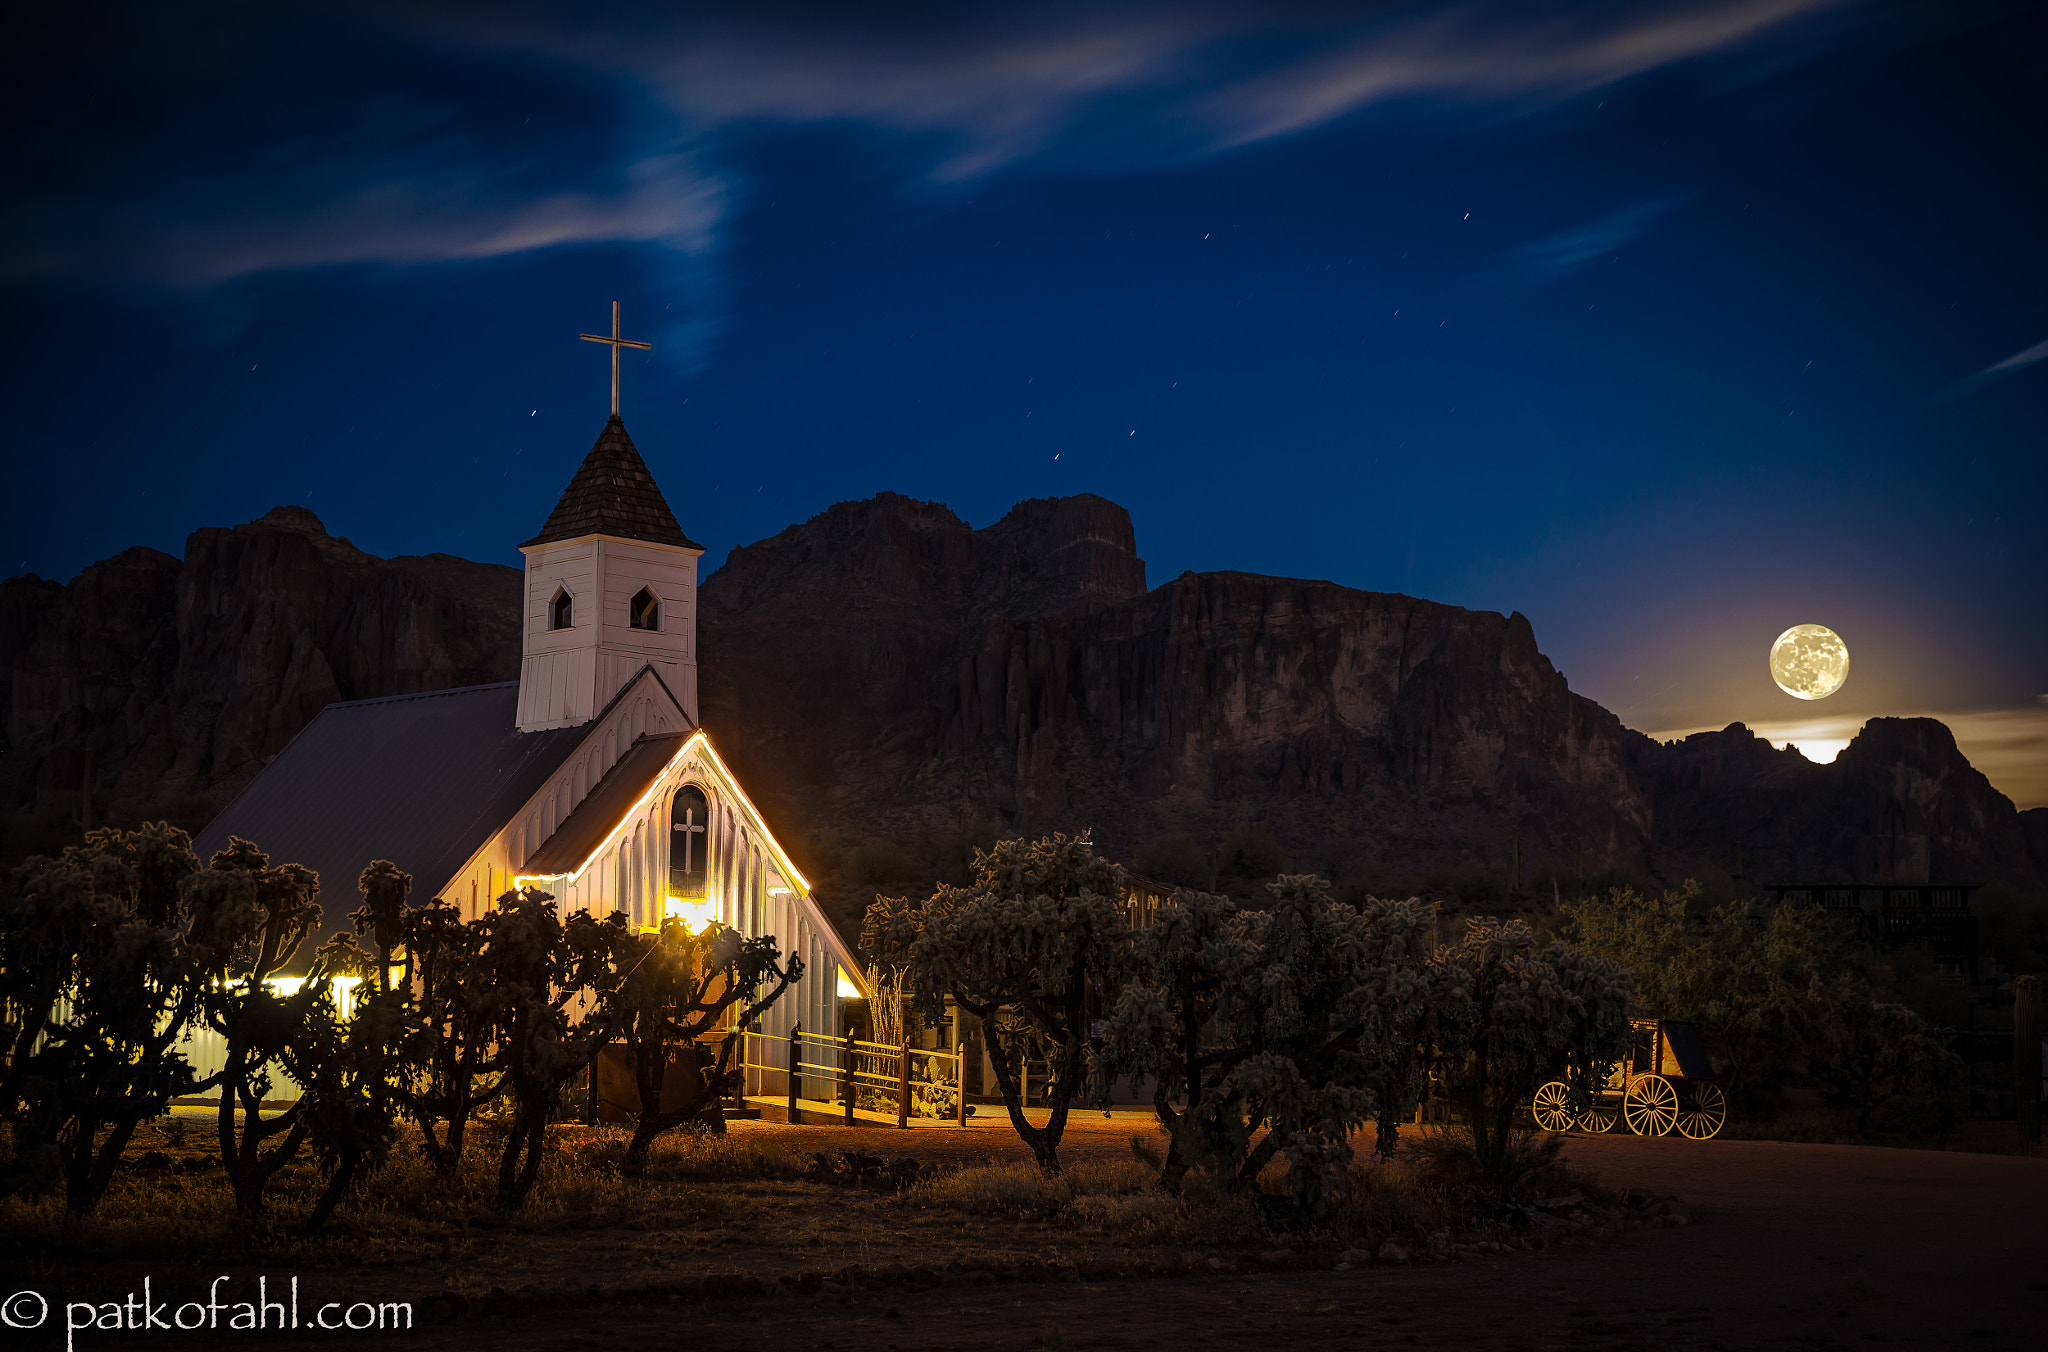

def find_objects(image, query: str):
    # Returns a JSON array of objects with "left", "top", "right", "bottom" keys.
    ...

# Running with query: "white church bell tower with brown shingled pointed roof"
[{"left": 518, "top": 414, "right": 705, "bottom": 731}]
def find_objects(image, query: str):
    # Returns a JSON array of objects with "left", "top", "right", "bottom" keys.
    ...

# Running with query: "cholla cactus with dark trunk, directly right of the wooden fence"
[{"left": 862, "top": 836, "right": 1128, "bottom": 1170}]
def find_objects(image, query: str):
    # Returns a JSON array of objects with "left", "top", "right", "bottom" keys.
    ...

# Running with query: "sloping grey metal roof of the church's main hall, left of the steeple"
[{"left": 195, "top": 680, "right": 592, "bottom": 925}]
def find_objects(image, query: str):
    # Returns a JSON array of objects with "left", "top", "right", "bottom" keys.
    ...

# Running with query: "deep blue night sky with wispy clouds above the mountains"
[{"left": 0, "top": 0, "right": 2048, "bottom": 807}]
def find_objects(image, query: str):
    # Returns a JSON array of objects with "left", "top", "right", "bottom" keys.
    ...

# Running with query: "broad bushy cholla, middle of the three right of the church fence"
[{"left": 1104, "top": 875, "right": 1438, "bottom": 1217}]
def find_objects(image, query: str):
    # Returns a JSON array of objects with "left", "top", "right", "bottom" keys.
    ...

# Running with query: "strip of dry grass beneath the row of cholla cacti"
[{"left": 0, "top": 1127, "right": 1548, "bottom": 1268}]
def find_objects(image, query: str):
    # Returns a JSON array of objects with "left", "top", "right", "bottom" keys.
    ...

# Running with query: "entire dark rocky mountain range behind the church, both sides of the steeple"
[{"left": 0, "top": 494, "right": 2048, "bottom": 887}]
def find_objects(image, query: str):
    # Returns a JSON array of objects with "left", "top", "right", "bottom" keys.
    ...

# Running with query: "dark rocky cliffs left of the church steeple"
[{"left": 0, "top": 506, "right": 520, "bottom": 817}]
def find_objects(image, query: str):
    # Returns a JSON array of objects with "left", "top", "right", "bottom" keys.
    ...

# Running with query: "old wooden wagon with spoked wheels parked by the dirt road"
[{"left": 1530, "top": 1018, "right": 1729, "bottom": 1141}]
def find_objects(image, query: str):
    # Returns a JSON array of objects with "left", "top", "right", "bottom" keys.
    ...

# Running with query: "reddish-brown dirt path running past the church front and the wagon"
[{"left": 422, "top": 1121, "right": 2048, "bottom": 1352}]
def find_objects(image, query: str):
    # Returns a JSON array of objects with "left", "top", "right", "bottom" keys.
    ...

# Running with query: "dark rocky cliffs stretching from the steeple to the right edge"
[{"left": 700, "top": 496, "right": 2042, "bottom": 885}]
